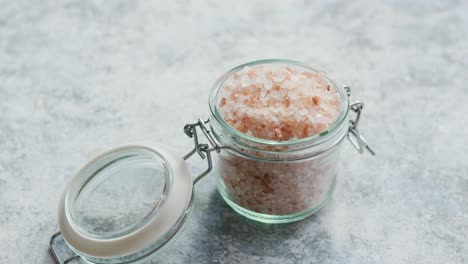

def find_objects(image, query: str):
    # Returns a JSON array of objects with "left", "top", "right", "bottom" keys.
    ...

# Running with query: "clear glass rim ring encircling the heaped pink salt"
[{"left": 208, "top": 59, "right": 349, "bottom": 146}]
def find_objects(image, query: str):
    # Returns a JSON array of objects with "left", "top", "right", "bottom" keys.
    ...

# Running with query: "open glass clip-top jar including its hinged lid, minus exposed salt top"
[{"left": 50, "top": 60, "right": 373, "bottom": 264}]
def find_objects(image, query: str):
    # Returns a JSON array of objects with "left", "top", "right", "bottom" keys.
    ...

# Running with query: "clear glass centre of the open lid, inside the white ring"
[{"left": 70, "top": 147, "right": 172, "bottom": 238}]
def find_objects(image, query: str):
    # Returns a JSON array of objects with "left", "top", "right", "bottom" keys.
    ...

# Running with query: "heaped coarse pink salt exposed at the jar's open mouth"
[{"left": 218, "top": 65, "right": 340, "bottom": 141}]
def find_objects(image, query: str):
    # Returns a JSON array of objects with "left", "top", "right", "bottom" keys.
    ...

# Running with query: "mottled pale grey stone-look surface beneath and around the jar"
[{"left": 0, "top": 0, "right": 468, "bottom": 264}]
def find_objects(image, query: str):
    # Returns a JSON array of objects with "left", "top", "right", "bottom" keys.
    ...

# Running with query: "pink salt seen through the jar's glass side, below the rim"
[{"left": 218, "top": 148, "right": 339, "bottom": 215}]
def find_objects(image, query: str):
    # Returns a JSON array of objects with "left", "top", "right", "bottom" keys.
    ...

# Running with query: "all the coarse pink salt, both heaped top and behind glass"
[{"left": 218, "top": 65, "right": 340, "bottom": 215}]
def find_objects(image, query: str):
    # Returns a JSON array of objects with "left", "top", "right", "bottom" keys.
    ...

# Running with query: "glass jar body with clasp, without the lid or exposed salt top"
[{"left": 209, "top": 60, "right": 370, "bottom": 223}]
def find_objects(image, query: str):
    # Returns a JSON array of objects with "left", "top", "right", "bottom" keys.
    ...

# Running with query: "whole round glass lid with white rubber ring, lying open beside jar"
[{"left": 59, "top": 145, "right": 193, "bottom": 263}]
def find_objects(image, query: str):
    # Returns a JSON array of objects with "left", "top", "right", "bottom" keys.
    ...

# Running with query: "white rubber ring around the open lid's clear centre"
[{"left": 58, "top": 144, "right": 193, "bottom": 258}]
